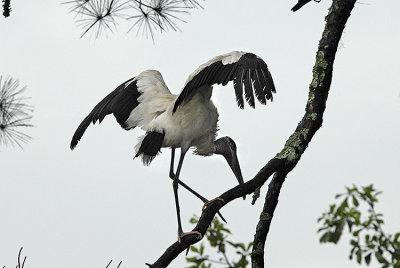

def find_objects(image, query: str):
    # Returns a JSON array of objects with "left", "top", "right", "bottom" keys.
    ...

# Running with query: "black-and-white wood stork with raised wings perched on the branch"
[{"left": 70, "top": 51, "right": 275, "bottom": 241}]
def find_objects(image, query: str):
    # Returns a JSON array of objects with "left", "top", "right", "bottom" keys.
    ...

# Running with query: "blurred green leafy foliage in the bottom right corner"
[{"left": 318, "top": 184, "right": 400, "bottom": 268}]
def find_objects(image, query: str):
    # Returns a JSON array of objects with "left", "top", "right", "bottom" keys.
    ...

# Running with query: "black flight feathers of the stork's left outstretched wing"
[{"left": 70, "top": 78, "right": 141, "bottom": 149}]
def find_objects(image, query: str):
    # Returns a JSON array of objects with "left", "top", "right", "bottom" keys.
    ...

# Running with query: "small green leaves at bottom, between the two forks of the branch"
[{"left": 186, "top": 217, "right": 253, "bottom": 268}]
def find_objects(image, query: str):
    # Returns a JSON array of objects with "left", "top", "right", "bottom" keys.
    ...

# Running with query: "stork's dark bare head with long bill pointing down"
[{"left": 214, "top": 136, "right": 245, "bottom": 199}]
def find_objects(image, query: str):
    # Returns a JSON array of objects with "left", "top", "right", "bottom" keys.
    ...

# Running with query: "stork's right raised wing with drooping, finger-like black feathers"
[{"left": 173, "top": 51, "right": 276, "bottom": 112}]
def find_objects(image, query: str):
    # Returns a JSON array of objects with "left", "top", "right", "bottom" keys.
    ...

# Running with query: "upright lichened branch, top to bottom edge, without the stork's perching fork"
[{"left": 251, "top": 0, "right": 356, "bottom": 268}]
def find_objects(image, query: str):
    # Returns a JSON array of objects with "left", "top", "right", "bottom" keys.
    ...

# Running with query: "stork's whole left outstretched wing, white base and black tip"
[{"left": 70, "top": 70, "right": 175, "bottom": 149}]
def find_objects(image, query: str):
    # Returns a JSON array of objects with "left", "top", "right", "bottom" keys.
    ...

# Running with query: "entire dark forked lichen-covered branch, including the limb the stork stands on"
[{"left": 150, "top": 0, "right": 356, "bottom": 268}]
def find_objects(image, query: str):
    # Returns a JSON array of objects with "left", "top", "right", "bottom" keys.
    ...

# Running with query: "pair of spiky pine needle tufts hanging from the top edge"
[{"left": 64, "top": 0, "right": 203, "bottom": 41}]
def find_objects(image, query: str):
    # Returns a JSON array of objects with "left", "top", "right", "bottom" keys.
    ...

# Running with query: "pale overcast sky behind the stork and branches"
[{"left": 0, "top": 0, "right": 400, "bottom": 268}]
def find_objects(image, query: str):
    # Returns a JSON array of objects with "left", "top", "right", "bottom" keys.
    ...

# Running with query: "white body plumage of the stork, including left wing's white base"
[{"left": 126, "top": 70, "right": 218, "bottom": 159}]
